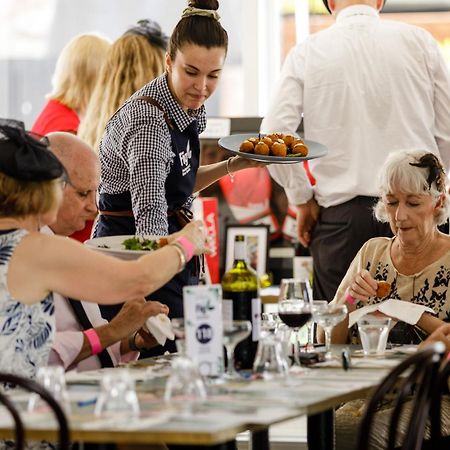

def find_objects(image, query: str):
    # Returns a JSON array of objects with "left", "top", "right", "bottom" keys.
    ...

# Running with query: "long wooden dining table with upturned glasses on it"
[{"left": 0, "top": 346, "right": 415, "bottom": 450}]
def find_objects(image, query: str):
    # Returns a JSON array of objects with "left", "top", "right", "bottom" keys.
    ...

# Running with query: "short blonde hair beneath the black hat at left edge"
[{"left": 0, "top": 172, "right": 62, "bottom": 218}]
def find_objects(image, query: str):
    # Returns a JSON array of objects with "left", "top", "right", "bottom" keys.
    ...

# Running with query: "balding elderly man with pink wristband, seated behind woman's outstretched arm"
[{"left": 42, "top": 133, "right": 168, "bottom": 370}]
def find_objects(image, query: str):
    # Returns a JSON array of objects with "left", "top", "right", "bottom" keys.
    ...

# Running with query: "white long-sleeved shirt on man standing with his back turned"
[{"left": 261, "top": 5, "right": 450, "bottom": 207}]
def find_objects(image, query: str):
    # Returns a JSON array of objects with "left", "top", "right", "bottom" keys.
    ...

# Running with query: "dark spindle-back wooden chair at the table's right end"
[{"left": 357, "top": 342, "right": 445, "bottom": 450}]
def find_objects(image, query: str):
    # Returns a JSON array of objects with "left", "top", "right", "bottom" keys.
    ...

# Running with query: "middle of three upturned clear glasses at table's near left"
[{"left": 94, "top": 368, "right": 140, "bottom": 418}]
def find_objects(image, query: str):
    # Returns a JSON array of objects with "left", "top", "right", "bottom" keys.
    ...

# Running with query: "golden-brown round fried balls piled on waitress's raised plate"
[{"left": 239, "top": 133, "right": 308, "bottom": 157}]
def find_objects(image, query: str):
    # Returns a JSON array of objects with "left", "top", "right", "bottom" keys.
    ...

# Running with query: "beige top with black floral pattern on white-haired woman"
[{"left": 333, "top": 237, "right": 450, "bottom": 343}]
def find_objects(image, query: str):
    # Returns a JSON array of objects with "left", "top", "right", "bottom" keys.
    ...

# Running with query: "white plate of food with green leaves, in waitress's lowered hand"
[{"left": 84, "top": 235, "right": 167, "bottom": 259}]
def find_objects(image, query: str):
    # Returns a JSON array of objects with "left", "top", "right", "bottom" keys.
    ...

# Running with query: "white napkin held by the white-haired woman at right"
[{"left": 348, "top": 298, "right": 434, "bottom": 328}]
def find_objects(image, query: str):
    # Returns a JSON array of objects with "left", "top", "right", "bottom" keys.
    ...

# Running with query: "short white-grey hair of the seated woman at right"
[{"left": 373, "top": 150, "right": 450, "bottom": 225}]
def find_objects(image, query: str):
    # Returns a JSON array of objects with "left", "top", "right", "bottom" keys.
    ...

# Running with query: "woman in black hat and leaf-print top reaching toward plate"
[{"left": 0, "top": 119, "right": 205, "bottom": 377}]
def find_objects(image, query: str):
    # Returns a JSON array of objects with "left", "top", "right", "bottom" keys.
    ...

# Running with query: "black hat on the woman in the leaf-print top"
[{"left": 0, "top": 119, "right": 66, "bottom": 181}]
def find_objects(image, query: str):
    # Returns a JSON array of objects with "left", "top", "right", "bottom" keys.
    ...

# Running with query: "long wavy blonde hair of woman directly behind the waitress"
[{"left": 78, "top": 34, "right": 165, "bottom": 152}]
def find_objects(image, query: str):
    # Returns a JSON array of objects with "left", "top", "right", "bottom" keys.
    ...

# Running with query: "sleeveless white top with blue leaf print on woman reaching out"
[{"left": 0, "top": 229, "right": 55, "bottom": 378}]
